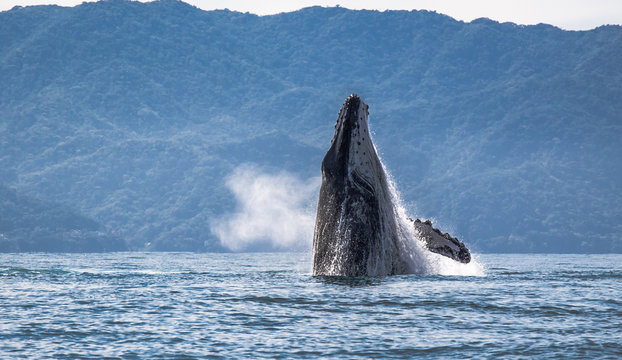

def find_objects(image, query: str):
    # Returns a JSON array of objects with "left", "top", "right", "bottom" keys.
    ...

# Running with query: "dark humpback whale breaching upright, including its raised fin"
[{"left": 313, "top": 95, "right": 471, "bottom": 276}]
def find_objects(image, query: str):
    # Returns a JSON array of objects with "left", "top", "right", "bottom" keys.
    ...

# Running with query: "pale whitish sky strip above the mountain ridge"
[{"left": 0, "top": 0, "right": 622, "bottom": 30}]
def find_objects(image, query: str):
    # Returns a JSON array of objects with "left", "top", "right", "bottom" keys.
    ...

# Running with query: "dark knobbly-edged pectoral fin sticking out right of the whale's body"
[{"left": 411, "top": 219, "right": 471, "bottom": 264}]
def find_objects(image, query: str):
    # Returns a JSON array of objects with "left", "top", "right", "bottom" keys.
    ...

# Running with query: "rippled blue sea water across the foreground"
[{"left": 0, "top": 253, "right": 622, "bottom": 359}]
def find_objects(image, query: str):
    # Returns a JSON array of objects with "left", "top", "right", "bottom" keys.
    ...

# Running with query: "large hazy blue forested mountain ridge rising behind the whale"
[{"left": 0, "top": 1, "right": 622, "bottom": 252}]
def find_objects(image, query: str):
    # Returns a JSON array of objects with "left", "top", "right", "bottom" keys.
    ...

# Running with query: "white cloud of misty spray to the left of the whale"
[{"left": 211, "top": 164, "right": 321, "bottom": 251}]
